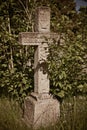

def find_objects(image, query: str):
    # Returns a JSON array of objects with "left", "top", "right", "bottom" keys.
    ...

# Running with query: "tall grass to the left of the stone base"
[{"left": 0, "top": 98, "right": 29, "bottom": 130}]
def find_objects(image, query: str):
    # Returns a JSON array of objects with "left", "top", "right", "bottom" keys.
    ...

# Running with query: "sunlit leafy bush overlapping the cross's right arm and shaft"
[{"left": 48, "top": 31, "right": 87, "bottom": 98}]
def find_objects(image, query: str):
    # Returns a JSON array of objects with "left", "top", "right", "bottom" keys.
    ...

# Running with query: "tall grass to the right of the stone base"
[{"left": 58, "top": 96, "right": 87, "bottom": 130}]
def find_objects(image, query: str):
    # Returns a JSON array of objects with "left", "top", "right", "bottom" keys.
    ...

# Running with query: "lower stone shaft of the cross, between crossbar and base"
[{"left": 34, "top": 44, "right": 49, "bottom": 94}]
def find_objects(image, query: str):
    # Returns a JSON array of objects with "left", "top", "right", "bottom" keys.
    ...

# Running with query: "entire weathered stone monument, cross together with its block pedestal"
[{"left": 19, "top": 7, "right": 60, "bottom": 128}]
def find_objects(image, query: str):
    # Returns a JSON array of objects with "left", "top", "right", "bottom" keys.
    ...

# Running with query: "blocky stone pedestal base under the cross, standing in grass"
[{"left": 24, "top": 93, "right": 60, "bottom": 128}]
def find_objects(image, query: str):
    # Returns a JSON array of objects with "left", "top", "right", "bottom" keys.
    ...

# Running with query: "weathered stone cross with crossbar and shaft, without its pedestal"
[{"left": 19, "top": 7, "right": 58, "bottom": 98}]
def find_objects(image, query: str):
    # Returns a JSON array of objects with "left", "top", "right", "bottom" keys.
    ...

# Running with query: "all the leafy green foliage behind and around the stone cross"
[{"left": 0, "top": 0, "right": 87, "bottom": 130}]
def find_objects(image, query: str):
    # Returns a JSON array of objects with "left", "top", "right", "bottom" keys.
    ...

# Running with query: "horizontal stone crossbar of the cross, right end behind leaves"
[{"left": 19, "top": 32, "right": 59, "bottom": 46}]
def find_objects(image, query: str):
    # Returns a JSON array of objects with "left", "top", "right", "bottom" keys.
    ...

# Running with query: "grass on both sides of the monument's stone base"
[{"left": 0, "top": 96, "right": 87, "bottom": 130}]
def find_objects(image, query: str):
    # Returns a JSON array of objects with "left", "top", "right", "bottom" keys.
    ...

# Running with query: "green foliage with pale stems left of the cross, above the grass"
[{"left": 0, "top": 0, "right": 34, "bottom": 100}]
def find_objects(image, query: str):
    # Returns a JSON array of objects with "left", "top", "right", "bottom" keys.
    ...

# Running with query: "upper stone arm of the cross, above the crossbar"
[{"left": 35, "top": 7, "right": 50, "bottom": 33}]
